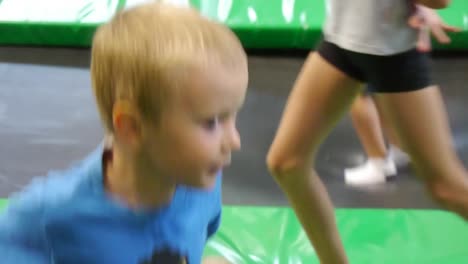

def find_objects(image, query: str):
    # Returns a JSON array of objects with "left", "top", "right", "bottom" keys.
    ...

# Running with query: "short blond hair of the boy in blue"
[{"left": 91, "top": 2, "right": 246, "bottom": 134}]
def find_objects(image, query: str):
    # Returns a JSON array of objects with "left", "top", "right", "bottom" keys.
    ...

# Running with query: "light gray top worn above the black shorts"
[{"left": 324, "top": 0, "right": 417, "bottom": 55}]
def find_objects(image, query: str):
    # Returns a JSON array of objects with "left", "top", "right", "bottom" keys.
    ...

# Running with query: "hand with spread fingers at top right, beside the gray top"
[{"left": 408, "top": 5, "right": 461, "bottom": 52}]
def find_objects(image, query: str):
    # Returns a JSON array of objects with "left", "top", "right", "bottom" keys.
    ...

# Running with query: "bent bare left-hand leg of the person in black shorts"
[{"left": 267, "top": 53, "right": 361, "bottom": 263}]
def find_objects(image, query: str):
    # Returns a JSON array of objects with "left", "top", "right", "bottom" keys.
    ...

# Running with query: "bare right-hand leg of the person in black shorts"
[{"left": 375, "top": 86, "right": 468, "bottom": 219}]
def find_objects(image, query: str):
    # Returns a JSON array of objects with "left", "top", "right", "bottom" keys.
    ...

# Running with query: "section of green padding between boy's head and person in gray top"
[{"left": 192, "top": 0, "right": 325, "bottom": 48}]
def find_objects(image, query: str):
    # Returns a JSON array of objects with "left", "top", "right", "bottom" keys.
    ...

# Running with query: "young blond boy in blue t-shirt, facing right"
[{"left": 0, "top": 3, "right": 248, "bottom": 264}]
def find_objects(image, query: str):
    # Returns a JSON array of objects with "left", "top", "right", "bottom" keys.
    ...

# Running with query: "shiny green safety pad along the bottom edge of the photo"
[{"left": 0, "top": 200, "right": 468, "bottom": 264}]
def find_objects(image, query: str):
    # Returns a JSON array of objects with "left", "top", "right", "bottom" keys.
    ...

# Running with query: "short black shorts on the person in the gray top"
[{"left": 317, "top": 41, "right": 433, "bottom": 93}]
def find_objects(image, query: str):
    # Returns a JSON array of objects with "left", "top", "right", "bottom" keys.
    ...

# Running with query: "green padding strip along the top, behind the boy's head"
[{"left": 0, "top": 0, "right": 468, "bottom": 49}]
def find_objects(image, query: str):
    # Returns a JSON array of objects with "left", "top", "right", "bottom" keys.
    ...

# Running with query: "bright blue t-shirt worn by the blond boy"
[{"left": 0, "top": 145, "right": 221, "bottom": 264}]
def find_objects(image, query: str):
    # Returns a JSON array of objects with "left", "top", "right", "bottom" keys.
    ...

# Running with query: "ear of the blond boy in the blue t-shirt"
[{"left": 112, "top": 101, "right": 141, "bottom": 149}]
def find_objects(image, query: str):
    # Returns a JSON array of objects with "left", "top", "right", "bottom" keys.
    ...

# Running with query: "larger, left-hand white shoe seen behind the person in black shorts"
[{"left": 345, "top": 158, "right": 397, "bottom": 185}]
